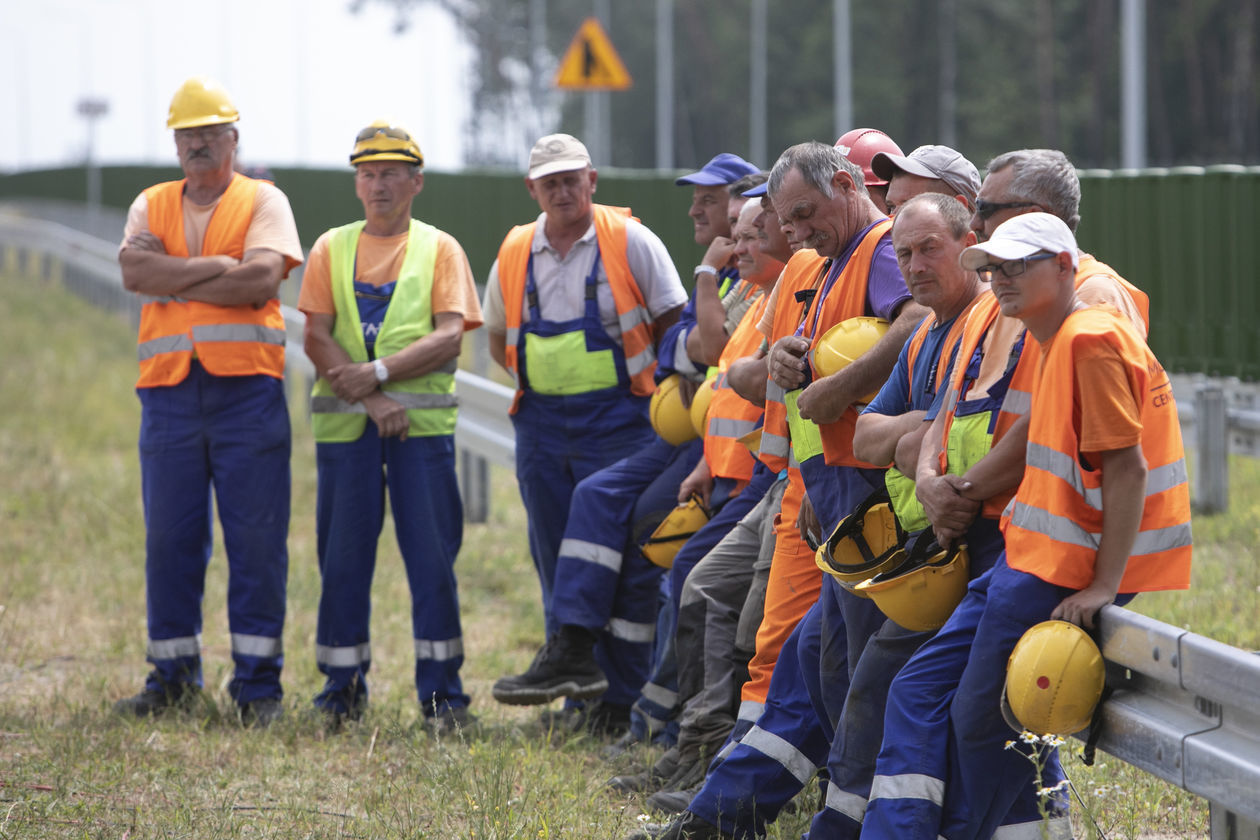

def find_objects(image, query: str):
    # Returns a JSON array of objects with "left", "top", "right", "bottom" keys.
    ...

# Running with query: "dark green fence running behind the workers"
[{"left": 0, "top": 165, "right": 1260, "bottom": 380}]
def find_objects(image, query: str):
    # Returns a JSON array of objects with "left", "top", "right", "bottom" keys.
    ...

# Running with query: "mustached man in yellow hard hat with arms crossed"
[{"left": 115, "top": 77, "right": 302, "bottom": 725}]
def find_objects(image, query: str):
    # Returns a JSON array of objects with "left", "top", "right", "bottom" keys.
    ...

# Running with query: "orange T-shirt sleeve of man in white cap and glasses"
[{"left": 1075, "top": 341, "right": 1142, "bottom": 452}]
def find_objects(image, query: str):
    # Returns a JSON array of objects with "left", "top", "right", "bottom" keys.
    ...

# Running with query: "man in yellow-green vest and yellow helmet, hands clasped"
[{"left": 299, "top": 120, "right": 481, "bottom": 730}]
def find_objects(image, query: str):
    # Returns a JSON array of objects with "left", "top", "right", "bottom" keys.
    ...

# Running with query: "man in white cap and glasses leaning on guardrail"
[{"left": 862, "top": 213, "right": 1191, "bottom": 840}]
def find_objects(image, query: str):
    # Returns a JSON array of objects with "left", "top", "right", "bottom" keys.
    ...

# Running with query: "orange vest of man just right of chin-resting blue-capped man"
[{"left": 704, "top": 290, "right": 769, "bottom": 481}]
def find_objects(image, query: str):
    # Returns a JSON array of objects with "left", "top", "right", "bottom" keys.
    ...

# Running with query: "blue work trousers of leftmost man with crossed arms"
[{"left": 136, "top": 360, "right": 291, "bottom": 705}]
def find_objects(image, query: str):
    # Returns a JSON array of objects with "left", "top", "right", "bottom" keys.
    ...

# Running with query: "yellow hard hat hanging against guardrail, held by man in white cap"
[{"left": 1002, "top": 621, "right": 1106, "bottom": 737}]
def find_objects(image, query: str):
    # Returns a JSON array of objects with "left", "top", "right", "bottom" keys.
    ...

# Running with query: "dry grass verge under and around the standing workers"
[{"left": 0, "top": 270, "right": 1260, "bottom": 839}]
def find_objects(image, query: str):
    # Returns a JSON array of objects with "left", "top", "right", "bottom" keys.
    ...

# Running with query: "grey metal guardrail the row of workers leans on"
[{"left": 0, "top": 214, "right": 1260, "bottom": 840}]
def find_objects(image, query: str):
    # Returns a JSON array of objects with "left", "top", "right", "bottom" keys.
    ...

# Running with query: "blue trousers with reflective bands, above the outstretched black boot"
[{"left": 552, "top": 437, "right": 703, "bottom": 707}]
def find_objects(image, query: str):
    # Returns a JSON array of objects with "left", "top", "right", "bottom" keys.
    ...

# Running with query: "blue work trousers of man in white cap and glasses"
[{"left": 862, "top": 555, "right": 1113, "bottom": 840}]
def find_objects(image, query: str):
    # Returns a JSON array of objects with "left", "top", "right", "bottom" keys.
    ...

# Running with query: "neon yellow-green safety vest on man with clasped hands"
[{"left": 311, "top": 219, "right": 457, "bottom": 443}]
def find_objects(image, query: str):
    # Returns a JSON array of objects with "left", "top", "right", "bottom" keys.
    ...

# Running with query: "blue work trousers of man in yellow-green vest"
[{"left": 315, "top": 430, "right": 469, "bottom": 717}]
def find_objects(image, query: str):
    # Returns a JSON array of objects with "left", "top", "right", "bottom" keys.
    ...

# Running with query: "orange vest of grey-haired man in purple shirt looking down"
[{"left": 761, "top": 219, "right": 892, "bottom": 468}]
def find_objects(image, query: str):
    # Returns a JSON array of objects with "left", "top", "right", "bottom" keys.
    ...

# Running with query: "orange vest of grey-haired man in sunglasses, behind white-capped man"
[{"left": 940, "top": 260, "right": 1150, "bottom": 519}]
